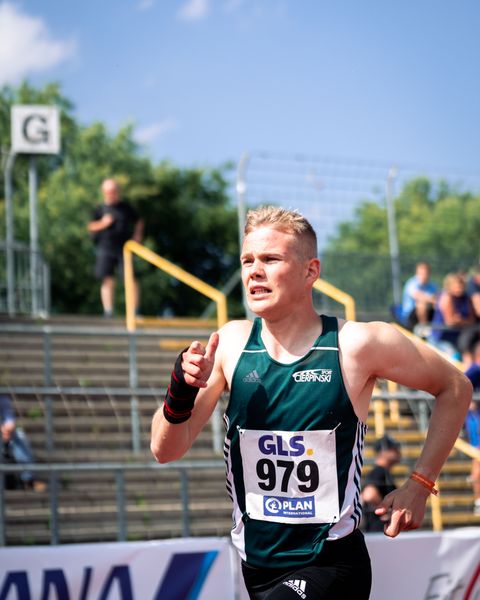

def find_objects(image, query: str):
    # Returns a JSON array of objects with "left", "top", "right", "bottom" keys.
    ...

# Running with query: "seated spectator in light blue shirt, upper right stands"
[{"left": 401, "top": 262, "right": 437, "bottom": 331}]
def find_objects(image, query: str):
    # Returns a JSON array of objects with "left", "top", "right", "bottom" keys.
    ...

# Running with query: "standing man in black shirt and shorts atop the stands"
[{"left": 88, "top": 179, "right": 144, "bottom": 317}]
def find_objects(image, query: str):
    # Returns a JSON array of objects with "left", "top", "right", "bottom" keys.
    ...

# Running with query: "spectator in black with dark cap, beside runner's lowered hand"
[{"left": 362, "top": 435, "right": 402, "bottom": 532}]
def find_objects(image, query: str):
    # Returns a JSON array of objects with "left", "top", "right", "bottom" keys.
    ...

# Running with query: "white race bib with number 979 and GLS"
[{"left": 239, "top": 429, "right": 340, "bottom": 523}]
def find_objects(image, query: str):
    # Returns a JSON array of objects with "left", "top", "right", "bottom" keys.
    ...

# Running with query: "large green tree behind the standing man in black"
[{"left": 0, "top": 83, "right": 238, "bottom": 315}]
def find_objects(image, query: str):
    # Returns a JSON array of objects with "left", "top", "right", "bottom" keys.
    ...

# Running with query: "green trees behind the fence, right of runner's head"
[{"left": 323, "top": 178, "right": 480, "bottom": 313}]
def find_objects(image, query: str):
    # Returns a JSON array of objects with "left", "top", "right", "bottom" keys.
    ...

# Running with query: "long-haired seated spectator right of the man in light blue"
[{"left": 429, "top": 273, "right": 476, "bottom": 359}]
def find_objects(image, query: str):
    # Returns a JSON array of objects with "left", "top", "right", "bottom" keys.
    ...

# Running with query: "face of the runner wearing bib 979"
[{"left": 240, "top": 227, "right": 311, "bottom": 317}]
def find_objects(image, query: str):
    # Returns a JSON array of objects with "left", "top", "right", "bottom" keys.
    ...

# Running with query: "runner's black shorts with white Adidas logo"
[{"left": 242, "top": 529, "right": 372, "bottom": 600}]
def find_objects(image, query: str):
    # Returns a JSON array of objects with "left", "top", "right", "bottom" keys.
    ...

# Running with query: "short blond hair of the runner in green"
[{"left": 244, "top": 206, "right": 317, "bottom": 259}]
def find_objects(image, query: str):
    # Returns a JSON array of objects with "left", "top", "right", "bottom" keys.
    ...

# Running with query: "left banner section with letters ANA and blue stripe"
[{"left": 0, "top": 538, "right": 235, "bottom": 600}]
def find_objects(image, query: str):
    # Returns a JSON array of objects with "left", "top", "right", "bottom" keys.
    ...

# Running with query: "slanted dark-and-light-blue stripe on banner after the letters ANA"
[{"left": 154, "top": 550, "right": 218, "bottom": 600}]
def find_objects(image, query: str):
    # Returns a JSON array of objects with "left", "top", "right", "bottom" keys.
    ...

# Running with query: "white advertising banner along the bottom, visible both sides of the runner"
[{"left": 0, "top": 527, "right": 480, "bottom": 600}]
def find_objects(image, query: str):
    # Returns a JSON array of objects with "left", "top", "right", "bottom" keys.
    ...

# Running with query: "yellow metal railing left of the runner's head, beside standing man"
[{"left": 123, "top": 240, "right": 228, "bottom": 331}]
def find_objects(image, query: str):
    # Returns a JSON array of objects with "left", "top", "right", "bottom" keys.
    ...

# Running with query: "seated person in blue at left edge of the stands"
[{"left": 0, "top": 396, "right": 46, "bottom": 491}]
